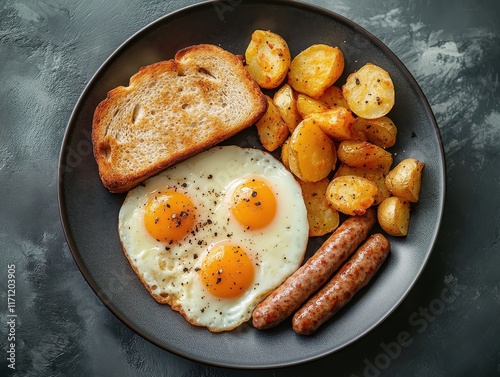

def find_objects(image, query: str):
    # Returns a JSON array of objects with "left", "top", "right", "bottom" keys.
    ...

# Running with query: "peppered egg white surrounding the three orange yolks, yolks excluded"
[{"left": 118, "top": 146, "right": 308, "bottom": 332}]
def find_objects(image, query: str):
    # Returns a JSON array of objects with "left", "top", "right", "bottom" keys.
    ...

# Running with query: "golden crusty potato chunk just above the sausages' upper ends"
[{"left": 326, "top": 175, "right": 378, "bottom": 216}]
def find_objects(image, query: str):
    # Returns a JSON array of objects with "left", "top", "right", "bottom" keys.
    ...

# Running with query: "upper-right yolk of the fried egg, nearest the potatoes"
[{"left": 231, "top": 179, "right": 276, "bottom": 230}]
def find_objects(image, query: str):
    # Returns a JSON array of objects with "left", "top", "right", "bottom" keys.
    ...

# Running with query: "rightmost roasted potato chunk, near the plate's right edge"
[{"left": 385, "top": 158, "right": 424, "bottom": 203}]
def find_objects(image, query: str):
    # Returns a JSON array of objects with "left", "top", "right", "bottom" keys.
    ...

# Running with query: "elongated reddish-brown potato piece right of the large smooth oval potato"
[{"left": 337, "top": 140, "right": 393, "bottom": 173}]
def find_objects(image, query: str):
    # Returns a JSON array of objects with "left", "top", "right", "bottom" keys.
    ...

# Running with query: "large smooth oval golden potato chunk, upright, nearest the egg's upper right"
[{"left": 288, "top": 121, "right": 337, "bottom": 182}]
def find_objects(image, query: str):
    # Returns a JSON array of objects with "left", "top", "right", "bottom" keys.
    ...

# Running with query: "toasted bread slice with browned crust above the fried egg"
[{"left": 92, "top": 44, "right": 267, "bottom": 193}]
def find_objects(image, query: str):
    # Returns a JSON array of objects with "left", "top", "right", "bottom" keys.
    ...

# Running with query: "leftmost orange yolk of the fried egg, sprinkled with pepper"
[{"left": 144, "top": 191, "right": 196, "bottom": 243}]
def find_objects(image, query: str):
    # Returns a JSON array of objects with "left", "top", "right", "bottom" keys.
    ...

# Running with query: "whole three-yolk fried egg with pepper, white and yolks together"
[{"left": 118, "top": 146, "right": 309, "bottom": 332}]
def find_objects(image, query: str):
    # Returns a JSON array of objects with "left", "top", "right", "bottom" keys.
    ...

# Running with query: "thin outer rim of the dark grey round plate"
[{"left": 57, "top": 0, "right": 447, "bottom": 370}]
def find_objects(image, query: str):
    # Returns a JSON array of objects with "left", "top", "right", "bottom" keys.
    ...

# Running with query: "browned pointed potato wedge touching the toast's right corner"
[{"left": 255, "top": 96, "right": 290, "bottom": 152}]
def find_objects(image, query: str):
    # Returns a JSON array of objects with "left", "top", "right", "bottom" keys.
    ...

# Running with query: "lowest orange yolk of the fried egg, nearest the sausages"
[{"left": 198, "top": 244, "right": 254, "bottom": 298}]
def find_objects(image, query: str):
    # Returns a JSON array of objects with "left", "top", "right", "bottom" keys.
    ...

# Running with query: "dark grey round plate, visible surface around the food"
[{"left": 58, "top": 0, "right": 445, "bottom": 369}]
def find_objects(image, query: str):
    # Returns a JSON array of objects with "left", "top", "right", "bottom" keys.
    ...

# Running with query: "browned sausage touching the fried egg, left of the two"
[{"left": 252, "top": 209, "right": 376, "bottom": 329}]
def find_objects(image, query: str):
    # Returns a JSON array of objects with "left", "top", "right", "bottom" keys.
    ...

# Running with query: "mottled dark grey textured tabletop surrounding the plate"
[{"left": 0, "top": 0, "right": 500, "bottom": 377}]
